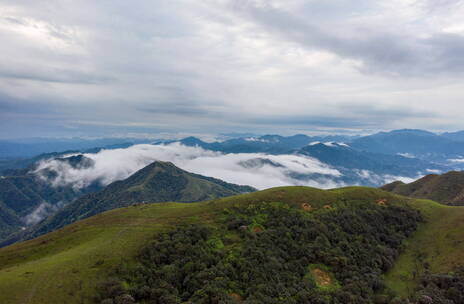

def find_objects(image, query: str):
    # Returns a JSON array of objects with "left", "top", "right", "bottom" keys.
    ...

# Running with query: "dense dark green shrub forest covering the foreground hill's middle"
[{"left": 97, "top": 202, "right": 432, "bottom": 304}]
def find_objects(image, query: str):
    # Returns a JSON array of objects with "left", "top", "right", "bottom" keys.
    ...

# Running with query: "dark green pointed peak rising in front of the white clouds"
[{"left": 6, "top": 161, "right": 255, "bottom": 244}]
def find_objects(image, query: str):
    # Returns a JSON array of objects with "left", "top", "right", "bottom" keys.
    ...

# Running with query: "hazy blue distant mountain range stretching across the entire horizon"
[{"left": 0, "top": 129, "right": 464, "bottom": 176}]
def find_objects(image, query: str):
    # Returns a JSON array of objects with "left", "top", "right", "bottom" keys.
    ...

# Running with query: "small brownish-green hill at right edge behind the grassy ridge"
[{"left": 382, "top": 171, "right": 464, "bottom": 205}]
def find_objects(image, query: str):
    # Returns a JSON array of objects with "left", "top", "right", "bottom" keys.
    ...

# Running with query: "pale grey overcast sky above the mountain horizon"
[{"left": 0, "top": 0, "right": 464, "bottom": 138}]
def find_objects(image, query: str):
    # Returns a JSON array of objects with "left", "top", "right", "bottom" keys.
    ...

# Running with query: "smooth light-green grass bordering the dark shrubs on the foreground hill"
[{"left": 0, "top": 187, "right": 464, "bottom": 303}]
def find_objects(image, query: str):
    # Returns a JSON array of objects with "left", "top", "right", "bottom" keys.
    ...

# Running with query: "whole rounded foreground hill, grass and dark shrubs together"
[{"left": 0, "top": 187, "right": 464, "bottom": 303}]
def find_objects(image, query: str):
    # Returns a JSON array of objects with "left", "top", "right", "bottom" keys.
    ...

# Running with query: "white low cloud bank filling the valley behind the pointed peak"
[{"left": 35, "top": 143, "right": 424, "bottom": 189}]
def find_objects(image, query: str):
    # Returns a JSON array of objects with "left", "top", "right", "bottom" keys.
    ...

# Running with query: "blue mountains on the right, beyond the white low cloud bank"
[{"left": 168, "top": 130, "right": 454, "bottom": 186}]
